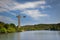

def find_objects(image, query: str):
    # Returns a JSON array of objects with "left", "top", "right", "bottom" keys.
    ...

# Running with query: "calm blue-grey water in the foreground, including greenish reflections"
[{"left": 0, "top": 31, "right": 60, "bottom": 40}]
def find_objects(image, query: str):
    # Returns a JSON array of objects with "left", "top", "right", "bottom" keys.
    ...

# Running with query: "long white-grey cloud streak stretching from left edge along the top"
[{"left": 0, "top": 0, "right": 50, "bottom": 12}]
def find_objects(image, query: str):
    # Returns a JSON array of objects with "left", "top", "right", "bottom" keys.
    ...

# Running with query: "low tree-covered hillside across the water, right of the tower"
[{"left": 20, "top": 23, "right": 60, "bottom": 31}]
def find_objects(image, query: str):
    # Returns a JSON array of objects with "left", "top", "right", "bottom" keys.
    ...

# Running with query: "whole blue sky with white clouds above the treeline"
[{"left": 0, "top": 0, "right": 60, "bottom": 25}]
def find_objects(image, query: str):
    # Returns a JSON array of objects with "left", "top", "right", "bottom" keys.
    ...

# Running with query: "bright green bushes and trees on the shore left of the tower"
[{"left": 0, "top": 22, "right": 16, "bottom": 33}]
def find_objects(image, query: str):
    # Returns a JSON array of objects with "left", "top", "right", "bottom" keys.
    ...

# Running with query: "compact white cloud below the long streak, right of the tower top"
[{"left": 22, "top": 10, "right": 48, "bottom": 19}]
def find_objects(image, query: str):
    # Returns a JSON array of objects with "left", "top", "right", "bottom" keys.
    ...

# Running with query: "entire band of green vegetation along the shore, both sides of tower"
[{"left": 0, "top": 22, "right": 60, "bottom": 33}]
